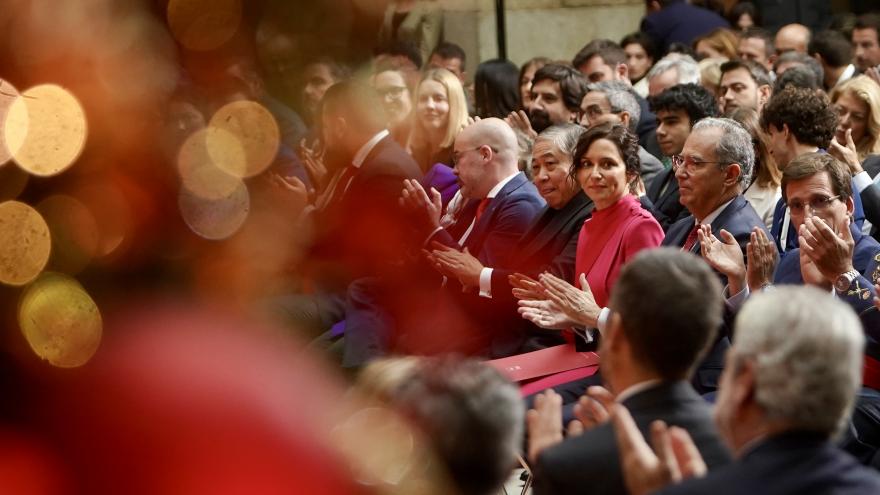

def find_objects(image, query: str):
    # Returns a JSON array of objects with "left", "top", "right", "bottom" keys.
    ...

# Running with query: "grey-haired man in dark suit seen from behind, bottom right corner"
[{"left": 612, "top": 287, "right": 880, "bottom": 495}]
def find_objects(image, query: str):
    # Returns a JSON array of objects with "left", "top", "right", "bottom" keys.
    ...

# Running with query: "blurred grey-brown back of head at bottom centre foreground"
[{"left": 394, "top": 358, "right": 524, "bottom": 495}]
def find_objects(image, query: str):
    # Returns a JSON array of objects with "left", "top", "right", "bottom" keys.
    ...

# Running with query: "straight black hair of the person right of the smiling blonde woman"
[{"left": 474, "top": 58, "right": 519, "bottom": 119}]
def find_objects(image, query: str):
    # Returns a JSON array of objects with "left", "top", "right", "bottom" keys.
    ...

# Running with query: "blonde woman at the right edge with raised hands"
[{"left": 831, "top": 76, "right": 880, "bottom": 170}]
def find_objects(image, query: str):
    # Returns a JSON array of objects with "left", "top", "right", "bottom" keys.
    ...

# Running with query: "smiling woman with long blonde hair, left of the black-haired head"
[{"left": 408, "top": 69, "right": 468, "bottom": 171}]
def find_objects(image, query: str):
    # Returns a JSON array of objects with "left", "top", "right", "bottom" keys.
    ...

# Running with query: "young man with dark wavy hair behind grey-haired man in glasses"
[{"left": 647, "top": 84, "right": 718, "bottom": 231}]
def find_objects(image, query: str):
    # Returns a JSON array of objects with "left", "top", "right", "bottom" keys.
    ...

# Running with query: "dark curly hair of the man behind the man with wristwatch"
[{"left": 761, "top": 87, "right": 837, "bottom": 148}]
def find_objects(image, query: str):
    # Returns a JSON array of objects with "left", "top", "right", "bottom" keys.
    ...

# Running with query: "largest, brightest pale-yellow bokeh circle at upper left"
[{"left": 3, "top": 84, "right": 87, "bottom": 177}]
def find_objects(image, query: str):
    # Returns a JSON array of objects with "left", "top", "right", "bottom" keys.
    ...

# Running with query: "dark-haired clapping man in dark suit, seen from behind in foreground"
[{"left": 528, "top": 249, "right": 730, "bottom": 494}]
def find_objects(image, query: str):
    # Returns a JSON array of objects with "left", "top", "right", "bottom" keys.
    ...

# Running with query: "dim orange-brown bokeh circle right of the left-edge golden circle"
[{"left": 37, "top": 194, "right": 100, "bottom": 274}]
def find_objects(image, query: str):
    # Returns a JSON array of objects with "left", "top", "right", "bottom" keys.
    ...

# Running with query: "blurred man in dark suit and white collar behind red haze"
[{"left": 269, "top": 81, "right": 421, "bottom": 335}]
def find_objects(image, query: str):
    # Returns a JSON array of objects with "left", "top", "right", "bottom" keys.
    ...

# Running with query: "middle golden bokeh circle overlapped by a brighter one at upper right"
[{"left": 177, "top": 129, "right": 245, "bottom": 200}]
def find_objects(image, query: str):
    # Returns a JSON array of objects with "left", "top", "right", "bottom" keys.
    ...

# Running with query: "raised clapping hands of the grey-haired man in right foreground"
[{"left": 611, "top": 404, "right": 706, "bottom": 495}]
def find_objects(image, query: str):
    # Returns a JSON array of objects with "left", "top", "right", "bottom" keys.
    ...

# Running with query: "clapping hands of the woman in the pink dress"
[{"left": 508, "top": 273, "right": 602, "bottom": 329}]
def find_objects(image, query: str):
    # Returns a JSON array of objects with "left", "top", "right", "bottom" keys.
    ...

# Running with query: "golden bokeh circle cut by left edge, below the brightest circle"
[{"left": 0, "top": 201, "right": 52, "bottom": 285}]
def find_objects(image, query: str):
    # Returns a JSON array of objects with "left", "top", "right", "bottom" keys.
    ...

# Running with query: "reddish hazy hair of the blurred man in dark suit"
[{"left": 321, "top": 80, "right": 385, "bottom": 133}]
